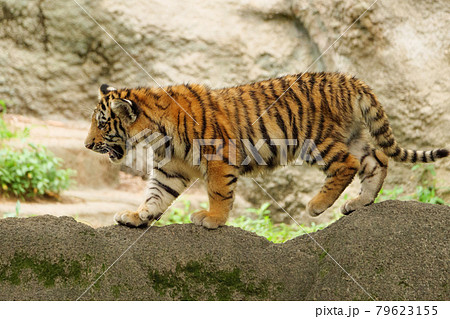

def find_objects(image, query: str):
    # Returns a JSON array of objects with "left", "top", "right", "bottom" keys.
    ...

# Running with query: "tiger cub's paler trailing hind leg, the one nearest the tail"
[{"left": 341, "top": 144, "right": 388, "bottom": 215}]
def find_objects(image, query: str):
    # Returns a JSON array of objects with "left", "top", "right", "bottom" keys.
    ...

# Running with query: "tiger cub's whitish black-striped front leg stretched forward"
[{"left": 114, "top": 167, "right": 190, "bottom": 228}]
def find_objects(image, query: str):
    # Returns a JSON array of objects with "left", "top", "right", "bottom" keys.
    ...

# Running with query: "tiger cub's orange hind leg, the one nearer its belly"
[{"left": 306, "top": 146, "right": 359, "bottom": 216}]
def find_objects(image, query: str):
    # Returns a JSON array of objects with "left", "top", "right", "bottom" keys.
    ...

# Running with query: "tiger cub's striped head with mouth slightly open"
[{"left": 84, "top": 84, "right": 138, "bottom": 163}]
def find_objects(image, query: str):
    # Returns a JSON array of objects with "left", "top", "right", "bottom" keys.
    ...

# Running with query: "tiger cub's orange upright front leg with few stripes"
[{"left": 191, "top": 162, "right": 238, "bottom": 229}]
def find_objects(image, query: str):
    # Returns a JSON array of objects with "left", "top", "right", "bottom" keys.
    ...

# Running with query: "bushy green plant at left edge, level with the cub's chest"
[{"left": 0, "top": 143, "right": 74, "bottom": 198}]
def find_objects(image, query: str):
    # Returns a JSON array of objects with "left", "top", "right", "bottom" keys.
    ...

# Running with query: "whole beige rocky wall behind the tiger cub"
[{"left": 0, "top": 0, "right": 450, "bottom": 224}]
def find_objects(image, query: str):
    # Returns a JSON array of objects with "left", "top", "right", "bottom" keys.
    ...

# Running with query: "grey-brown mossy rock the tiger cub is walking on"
[{"left": 0, "top": 201, "right": 450, "bottom": 300}]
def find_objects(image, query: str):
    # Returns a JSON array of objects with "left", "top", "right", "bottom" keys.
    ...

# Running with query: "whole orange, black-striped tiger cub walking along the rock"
[{"left": 85, "top": 72, "right": 449, "bottom": 229}]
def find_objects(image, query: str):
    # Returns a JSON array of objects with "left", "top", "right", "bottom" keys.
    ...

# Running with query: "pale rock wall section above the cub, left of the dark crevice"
[{"left": 0, "top": 0, "right": 312, "bottom": 118}]
